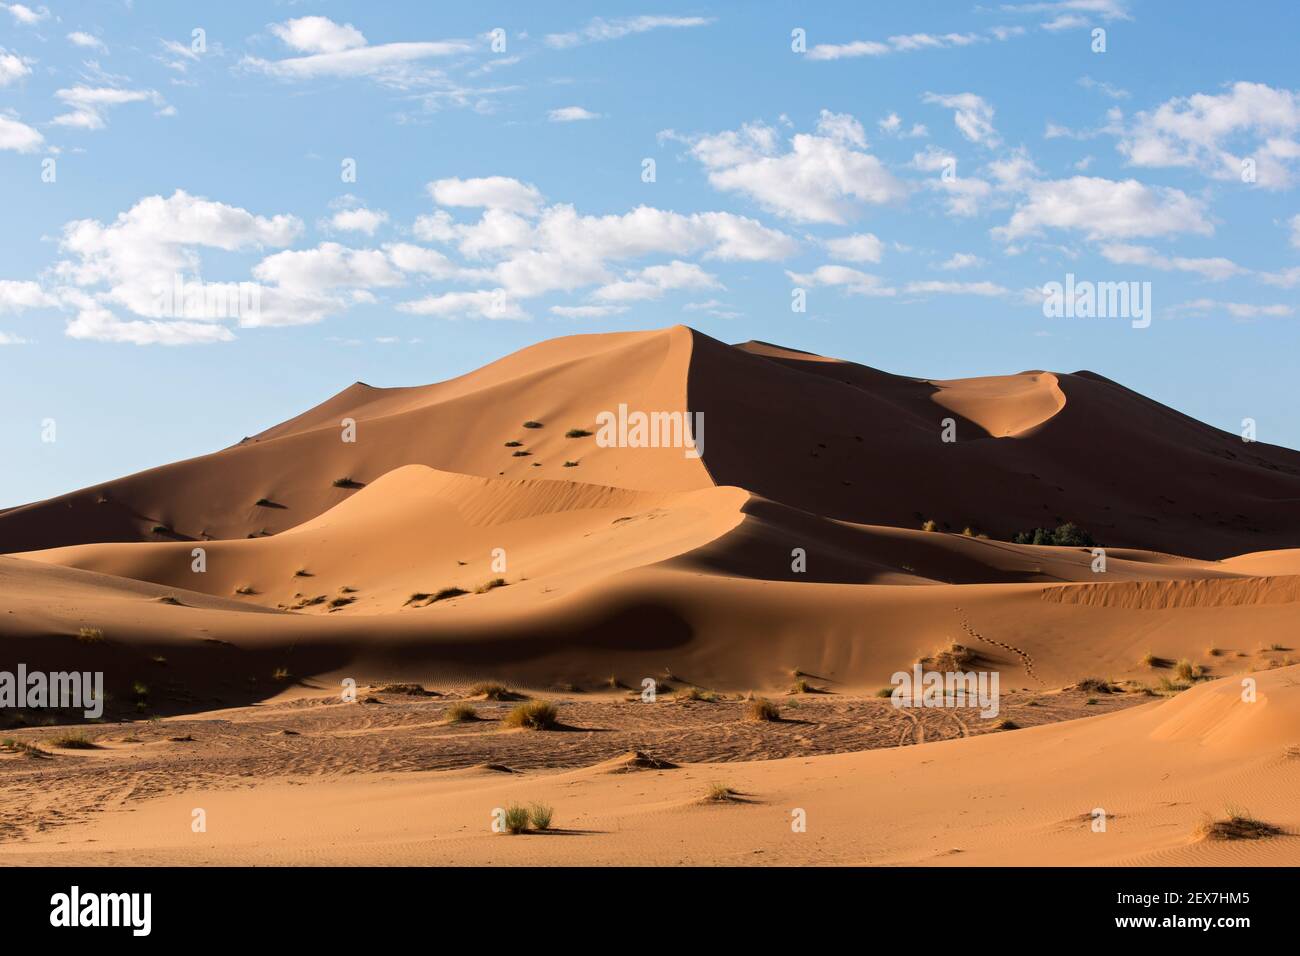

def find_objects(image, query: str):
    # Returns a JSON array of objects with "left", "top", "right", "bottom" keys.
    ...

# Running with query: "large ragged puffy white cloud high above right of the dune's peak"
[{"left": 660, "top": 109, "right": 906, "bottom": 224}]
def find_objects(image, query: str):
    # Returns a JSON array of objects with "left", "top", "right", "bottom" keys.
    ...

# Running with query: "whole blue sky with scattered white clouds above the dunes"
[{"left": 0, "top": 0, "right": 1300, "bottom": 506}]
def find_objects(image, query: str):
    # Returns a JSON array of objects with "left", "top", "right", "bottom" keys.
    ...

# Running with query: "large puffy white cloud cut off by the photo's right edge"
[{"left": 1118, "top": 82, "right": 1300, "bottom": 189}]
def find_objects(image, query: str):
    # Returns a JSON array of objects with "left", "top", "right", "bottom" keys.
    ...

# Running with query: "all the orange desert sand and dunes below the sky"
[{"left": 0, "top": 326, "right": 1300, "bottom": 865}]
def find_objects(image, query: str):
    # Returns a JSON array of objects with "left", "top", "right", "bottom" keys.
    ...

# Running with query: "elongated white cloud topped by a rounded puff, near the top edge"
[{"left": 241, "top": 17, "right": 475, "bottom": 88}]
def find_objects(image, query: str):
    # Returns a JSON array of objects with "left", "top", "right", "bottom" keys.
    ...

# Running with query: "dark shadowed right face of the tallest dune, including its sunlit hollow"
[{"left": 688, "top": 327, "right": 1300, "bottom": 558}]
